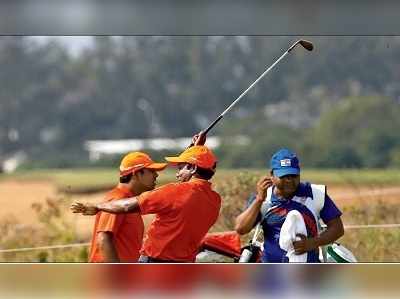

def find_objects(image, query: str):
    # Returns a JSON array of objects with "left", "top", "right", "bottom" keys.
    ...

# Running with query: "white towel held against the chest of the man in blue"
[{"left": 279, "top": 210, "right": 307, "bottom": 263}]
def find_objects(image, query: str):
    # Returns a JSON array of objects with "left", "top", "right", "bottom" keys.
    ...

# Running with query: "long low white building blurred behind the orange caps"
[{"left": 84, "top": 136, "right": 220, "bottom": 162}]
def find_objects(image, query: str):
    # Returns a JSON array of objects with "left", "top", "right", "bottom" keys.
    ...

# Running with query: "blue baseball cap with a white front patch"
[{"left": 270, "top": 148, "right": 300, "bottom": 177}]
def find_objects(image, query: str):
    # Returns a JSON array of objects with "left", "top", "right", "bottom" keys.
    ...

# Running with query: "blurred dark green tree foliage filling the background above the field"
[{"left": 0, "top": 36, "right": 400, "bottom": 168}]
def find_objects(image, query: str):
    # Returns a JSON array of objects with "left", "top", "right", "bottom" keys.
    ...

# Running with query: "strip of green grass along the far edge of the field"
[{"left": 0, "top": 168, "right": 400, "bottom": 192}]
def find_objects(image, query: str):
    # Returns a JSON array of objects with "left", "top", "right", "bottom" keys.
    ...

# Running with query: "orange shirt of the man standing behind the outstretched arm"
[{"left": 89, "top": 187, "right": 144, "bottom": 263}]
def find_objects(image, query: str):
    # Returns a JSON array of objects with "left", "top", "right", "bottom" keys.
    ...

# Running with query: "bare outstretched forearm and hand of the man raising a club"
[{"left": 71, "top": 197, "right": 139, "bottom": 215}]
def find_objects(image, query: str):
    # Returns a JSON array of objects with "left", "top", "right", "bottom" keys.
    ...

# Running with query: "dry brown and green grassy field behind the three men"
[{"left": 0, "top": 169, "right": 400, "bottom": 262}]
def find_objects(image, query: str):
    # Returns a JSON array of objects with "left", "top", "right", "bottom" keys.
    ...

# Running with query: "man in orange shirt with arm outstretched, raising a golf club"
[{"left": 71, "top": 145, "right": 221, "bottom": 262}]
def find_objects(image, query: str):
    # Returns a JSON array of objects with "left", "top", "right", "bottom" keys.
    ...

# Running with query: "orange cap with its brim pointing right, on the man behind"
[{"left": 119, "top": 152, "right": 168, "bottom": 176}]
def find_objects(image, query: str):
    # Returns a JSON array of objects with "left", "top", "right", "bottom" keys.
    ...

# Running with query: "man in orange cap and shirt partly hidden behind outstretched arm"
[{"left": 89, "top": 152, "right": 167, "bottom": 263}]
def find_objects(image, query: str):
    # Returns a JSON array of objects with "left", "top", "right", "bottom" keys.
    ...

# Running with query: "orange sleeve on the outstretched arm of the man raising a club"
[{"left": 138, "top": 183, "right": 175, "bottom": 214}]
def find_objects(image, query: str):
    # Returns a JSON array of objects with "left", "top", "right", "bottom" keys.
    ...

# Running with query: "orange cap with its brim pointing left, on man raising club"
[{"left": 165, "top": 145, "right": 217, "bottom": 169}]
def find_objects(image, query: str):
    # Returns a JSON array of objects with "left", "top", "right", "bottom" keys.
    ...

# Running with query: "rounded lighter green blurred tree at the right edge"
[{"left": 303, "top": 97, "right": 400, "bottom": 167}]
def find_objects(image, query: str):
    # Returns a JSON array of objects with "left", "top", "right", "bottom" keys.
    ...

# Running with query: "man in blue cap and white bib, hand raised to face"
[{"left": 235, "top": 148, "right": 344, "bottom": 263}]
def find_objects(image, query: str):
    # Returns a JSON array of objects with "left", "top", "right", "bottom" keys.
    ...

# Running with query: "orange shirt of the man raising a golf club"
[{"left": 138, "top": 179, "right": 221, "bottom": 262}]
